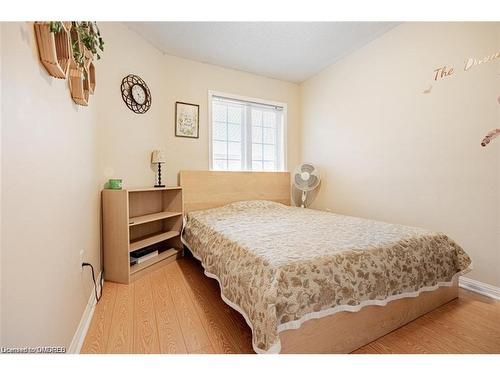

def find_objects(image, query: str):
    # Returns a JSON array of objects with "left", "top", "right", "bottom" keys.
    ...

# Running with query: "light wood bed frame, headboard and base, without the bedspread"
[{"left": 179, "top": 171, "right": 458, "bottom": 353}]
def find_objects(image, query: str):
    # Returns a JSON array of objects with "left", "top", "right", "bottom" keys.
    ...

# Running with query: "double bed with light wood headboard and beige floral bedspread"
[{"left": 180, "top": 171, "right": 471, "bottom": 353}]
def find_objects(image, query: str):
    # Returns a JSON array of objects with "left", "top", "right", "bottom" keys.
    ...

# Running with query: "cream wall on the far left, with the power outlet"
[{"left": 1, "top": 23, "right": 100, "bottom": 346}]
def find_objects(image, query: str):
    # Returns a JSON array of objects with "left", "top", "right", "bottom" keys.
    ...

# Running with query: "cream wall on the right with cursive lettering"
[{"left": 301, "top": 23, "right": 500, "bottom": 286}]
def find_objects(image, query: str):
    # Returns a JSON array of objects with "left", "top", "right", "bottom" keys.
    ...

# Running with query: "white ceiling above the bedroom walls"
[{"left": 126, "top": 22, "right": 397, "bottom": 82}]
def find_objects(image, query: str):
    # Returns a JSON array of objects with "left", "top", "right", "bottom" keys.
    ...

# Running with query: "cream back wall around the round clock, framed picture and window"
[{"left": 96, "top": 22, "right": 299, "bottom": 187}]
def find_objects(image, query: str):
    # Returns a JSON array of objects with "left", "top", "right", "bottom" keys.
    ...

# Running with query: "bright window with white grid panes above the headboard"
[{"left": 209, "top": 93, "right": 286, "bottom": 171}]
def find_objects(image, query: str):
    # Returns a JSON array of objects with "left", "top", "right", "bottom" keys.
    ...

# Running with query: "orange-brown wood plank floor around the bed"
[{"left": 81, "top": 258, "right": 500, "bottom": 354}]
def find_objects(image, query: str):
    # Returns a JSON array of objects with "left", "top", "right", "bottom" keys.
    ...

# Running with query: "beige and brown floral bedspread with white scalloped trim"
[{"left": 183, "top": 201, "right": 471, "bottom": 352}]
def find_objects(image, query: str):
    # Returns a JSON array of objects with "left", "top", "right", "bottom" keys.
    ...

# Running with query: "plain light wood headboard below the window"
[{"left": 179, "top": 171, "right": 290, "bottom": 213}]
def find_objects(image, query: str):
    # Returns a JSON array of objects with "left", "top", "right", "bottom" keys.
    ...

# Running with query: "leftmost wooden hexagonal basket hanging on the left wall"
[{"left": 34, "top": 22, "right": 72, "bottom": 79}]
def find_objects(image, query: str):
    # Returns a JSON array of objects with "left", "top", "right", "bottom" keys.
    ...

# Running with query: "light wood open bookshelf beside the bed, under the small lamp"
[{"left": 102, "top": 186, "right": 182, "bottom": 284}]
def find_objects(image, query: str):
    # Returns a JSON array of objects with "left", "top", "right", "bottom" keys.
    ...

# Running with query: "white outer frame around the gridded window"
[{"left": 207, "top": 90, "right": 288, "bottom": 172}]
